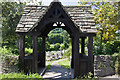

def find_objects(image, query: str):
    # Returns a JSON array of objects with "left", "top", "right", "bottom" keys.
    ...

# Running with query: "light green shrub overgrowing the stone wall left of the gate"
[{"left": 0, "top": 47, "right": 19, "bottom": 72}]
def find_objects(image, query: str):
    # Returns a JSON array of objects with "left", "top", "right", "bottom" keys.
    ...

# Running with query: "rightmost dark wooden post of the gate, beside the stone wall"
[{"left": 88, "top": 36, "right": 94, "bottom": 74}]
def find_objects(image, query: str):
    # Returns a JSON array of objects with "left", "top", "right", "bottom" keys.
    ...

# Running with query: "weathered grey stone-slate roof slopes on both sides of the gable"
[{"left": 16, "top": 2, "right": 97, "bottom": 33}]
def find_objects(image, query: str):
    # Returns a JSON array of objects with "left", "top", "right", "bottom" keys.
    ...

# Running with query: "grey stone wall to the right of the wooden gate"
[{"left": 94, "top": 55, "right": 115, "bottom": 77}]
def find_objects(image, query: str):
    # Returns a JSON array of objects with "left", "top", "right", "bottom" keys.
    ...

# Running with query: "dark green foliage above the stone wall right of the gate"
[{"left": 93, "top": 40, "right": 120, "bottom": 55}]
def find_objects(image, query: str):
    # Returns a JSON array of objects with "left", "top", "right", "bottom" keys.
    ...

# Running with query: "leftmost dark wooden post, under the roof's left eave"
[{"left": 19, "top": 35, "right": 25, "bottom": 70}]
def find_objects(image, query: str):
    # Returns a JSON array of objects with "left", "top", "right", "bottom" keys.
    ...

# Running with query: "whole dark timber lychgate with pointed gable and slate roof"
[{"left": 16, "top": 1, "right": 97, "bottom": 77}]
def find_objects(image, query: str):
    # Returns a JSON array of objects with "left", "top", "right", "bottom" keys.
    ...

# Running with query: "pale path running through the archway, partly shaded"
[{"left": 43, "top": 59, "right": 71, "bottom": 79}]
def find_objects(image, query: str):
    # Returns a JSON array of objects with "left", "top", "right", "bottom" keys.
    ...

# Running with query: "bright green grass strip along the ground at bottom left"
[{"left": 0, "top": 73, "right": 42, "bottom": 79}]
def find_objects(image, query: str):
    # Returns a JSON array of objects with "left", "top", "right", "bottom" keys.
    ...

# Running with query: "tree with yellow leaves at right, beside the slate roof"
[{"left": 80, "top": 2, "right": 120, "bottom": 42}]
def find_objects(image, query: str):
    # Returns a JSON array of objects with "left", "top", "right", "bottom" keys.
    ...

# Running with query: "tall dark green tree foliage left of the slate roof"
[{"left": 2, "top": 2, "right": 25, "bottom": 48}]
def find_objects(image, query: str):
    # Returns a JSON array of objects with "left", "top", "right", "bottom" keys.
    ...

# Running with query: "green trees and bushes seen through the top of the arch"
[{"left": 47, "top": 28, "right": 70, "bottom": 51}]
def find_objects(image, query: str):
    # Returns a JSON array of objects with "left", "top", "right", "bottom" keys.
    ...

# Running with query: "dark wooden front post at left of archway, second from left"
[{"left": 32, "top": 36, "right": 38, "bottom": 73}]
